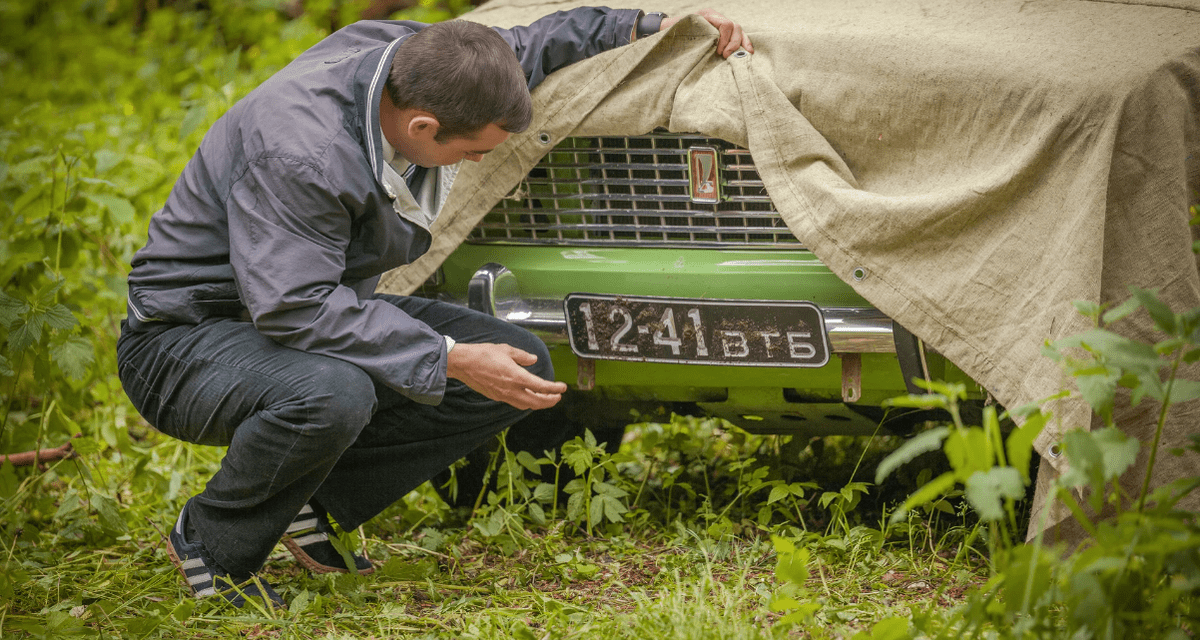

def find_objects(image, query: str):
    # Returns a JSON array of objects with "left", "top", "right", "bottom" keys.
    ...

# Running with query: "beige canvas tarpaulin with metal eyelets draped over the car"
[{"left": 382, "top": 0, "right": 1200, "bottom": 537}]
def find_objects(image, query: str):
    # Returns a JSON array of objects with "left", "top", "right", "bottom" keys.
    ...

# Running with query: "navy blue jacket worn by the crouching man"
[{"left": 128, "top": 7, "right": 640, "bottom": 403}]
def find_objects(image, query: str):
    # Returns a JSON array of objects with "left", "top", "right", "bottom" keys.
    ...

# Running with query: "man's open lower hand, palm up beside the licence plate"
[{"left": 446, "top": 342, "right": 566, "bottom": 409}]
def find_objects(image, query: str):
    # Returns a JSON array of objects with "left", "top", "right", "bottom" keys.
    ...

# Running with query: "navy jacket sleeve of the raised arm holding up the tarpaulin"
[{"left": 496, "top": 7, "right": 642, "bottom": 90}]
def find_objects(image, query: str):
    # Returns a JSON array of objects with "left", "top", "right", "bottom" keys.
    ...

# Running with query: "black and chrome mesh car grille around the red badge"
[{"left": 467, "top": 133, "right": 800, "bottom": 249}]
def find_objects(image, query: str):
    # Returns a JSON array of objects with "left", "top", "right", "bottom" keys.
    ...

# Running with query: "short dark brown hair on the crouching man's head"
[{"left": 385, "top": 20, "right": 533, "bottom": 142}]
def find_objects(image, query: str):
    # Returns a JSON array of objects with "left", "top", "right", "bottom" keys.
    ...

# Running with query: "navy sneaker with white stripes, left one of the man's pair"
[{"left": 167, "top": 501, "right": 287, "bottom": 609}]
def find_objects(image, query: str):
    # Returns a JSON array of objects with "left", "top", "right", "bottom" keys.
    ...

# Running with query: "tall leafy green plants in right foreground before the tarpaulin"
[{"left": 878, "top": 273, "right": 1200, "bottom": 639}]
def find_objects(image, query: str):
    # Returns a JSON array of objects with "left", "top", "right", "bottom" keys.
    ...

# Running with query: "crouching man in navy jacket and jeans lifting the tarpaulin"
[{"left": 118, "top": 7, "right": 752, "bottom": 606}]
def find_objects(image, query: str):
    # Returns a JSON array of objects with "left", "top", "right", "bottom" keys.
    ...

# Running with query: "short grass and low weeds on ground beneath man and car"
[{"left": 0, "top": 419, "right": 986, "bottom": 640}]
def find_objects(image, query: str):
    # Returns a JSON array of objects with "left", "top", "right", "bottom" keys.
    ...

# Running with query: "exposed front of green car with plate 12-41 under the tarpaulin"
[{"left": 420, "top": 132, "right": 985, "bottom": 436}]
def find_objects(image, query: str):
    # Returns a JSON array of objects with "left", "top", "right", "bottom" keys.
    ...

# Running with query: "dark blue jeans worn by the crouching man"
[{"left": 116, "top": 295, "right": 556, "bottom": 575}]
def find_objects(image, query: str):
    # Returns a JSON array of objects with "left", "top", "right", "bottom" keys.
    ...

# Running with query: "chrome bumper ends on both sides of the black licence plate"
[{"left": 467, "top": 263, "right": 913, "bottom": 353}]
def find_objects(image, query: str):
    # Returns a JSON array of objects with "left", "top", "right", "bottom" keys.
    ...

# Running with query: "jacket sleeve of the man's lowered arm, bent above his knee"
[{"left": 226, "top": 157, "right": 446, "bottom": 405}]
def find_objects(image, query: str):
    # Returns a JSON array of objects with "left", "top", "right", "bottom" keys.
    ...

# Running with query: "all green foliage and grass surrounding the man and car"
[{"left": 0, "top": 0, "right": 1200, "bottom": 639}]
